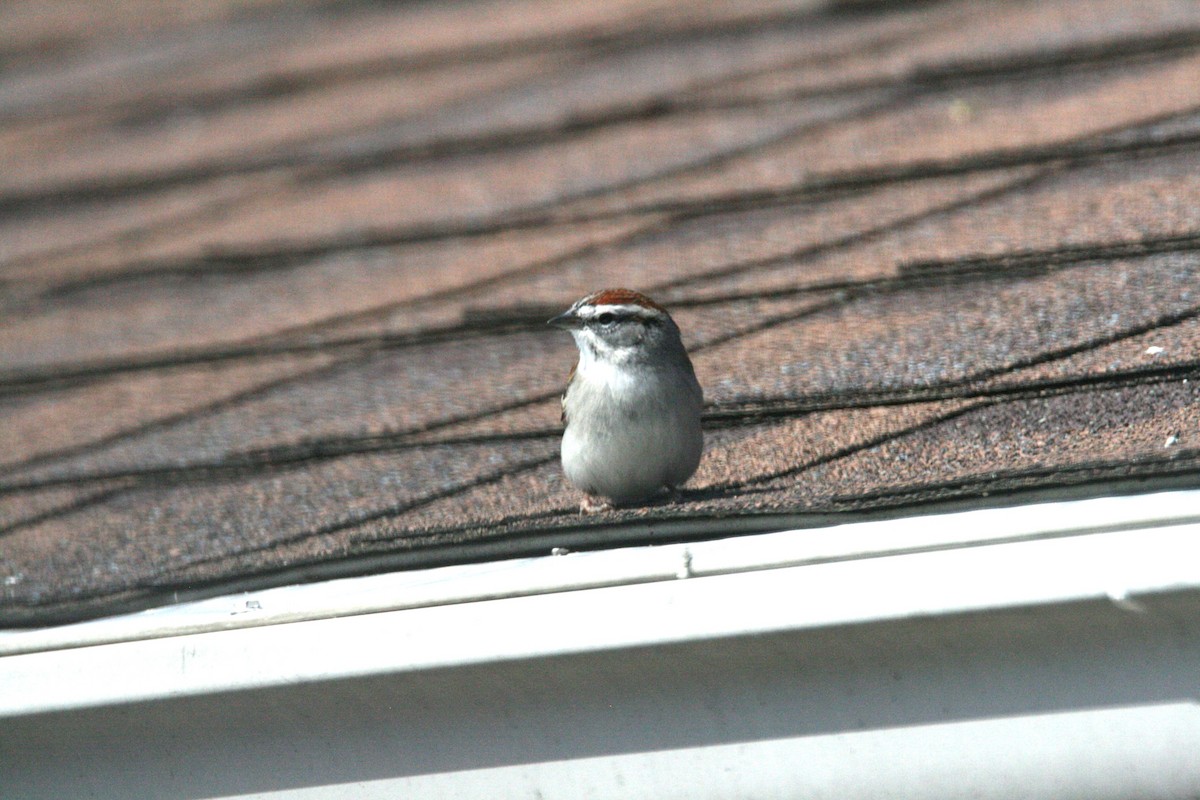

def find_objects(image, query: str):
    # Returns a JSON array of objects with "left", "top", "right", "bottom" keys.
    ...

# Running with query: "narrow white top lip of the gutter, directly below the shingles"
[{"left": 0, "top": 489, "right": 1200, "bottom": 672}]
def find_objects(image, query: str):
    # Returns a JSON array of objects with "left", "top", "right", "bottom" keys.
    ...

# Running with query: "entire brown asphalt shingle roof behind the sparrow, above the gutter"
[{"left": 0, "top": 0, "right": 1200, "bottom": 625}]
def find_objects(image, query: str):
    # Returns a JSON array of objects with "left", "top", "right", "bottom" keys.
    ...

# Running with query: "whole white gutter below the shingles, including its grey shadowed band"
[{"left": 0, "top": 492, "right": 1200, "bottom": 800}]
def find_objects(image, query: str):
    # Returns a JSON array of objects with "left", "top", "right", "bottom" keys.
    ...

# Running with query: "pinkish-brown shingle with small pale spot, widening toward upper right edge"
[{"left": 566, "top": 54, "right": 1200, "bottom": 217}]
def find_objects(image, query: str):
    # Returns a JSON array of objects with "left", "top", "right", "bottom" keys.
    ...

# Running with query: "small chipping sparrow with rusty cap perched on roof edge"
[{"left": 550, "top": 289, "right": 704, "bottom": 511}]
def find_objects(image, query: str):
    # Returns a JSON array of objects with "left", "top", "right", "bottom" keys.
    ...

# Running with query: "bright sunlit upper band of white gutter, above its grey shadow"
[{"left": 0, "top": 492, "right": 1200, "bottom": 716}]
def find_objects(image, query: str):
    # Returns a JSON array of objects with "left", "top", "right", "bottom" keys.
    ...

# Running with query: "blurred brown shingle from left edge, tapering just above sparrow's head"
[{"left": 0, "top": 222, "right": 625, "bottom": 371}]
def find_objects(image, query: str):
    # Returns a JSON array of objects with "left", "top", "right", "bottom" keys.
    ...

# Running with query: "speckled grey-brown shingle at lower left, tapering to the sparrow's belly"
[{"left": 2, "top": 443, "right": 550, "bottom": 606}]
